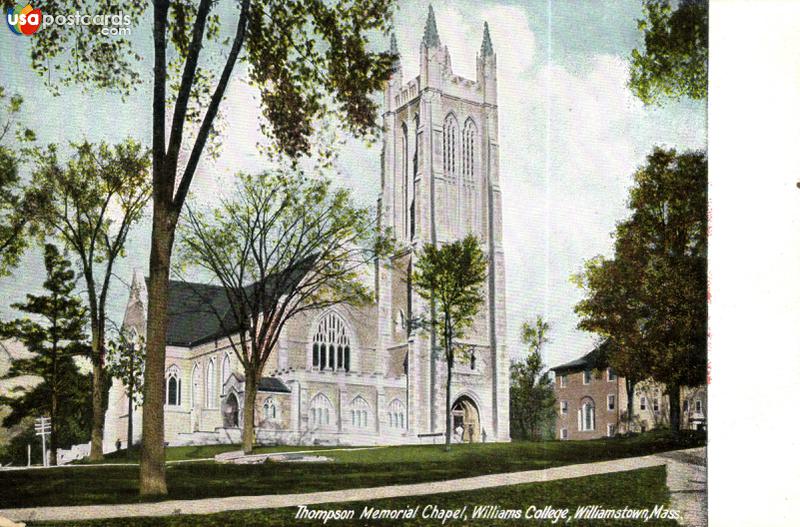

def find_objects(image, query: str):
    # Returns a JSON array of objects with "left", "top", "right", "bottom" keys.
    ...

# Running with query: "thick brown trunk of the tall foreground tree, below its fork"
[{"left": 139, "top": 206, "right": 175, "bottom": 496}]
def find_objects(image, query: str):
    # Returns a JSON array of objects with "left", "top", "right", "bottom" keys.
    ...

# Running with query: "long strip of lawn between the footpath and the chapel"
[{"left": 0, "top": 432, "right": 704, "bottom": 508}]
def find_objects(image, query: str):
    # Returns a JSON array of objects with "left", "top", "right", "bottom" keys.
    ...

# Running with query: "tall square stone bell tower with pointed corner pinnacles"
[{"left": 378, "top": 7, "right": 509, "bottom": 441}]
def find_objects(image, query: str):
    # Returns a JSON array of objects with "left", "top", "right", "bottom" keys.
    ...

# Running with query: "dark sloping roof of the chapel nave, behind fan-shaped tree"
[{"left": 152, "top": 257, "right": 313, "bottom": 347}]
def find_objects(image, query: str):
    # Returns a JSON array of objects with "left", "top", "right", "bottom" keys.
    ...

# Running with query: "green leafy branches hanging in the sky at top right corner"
[{"left": 629, "top": 0, "right": 708, "bottom": 104}]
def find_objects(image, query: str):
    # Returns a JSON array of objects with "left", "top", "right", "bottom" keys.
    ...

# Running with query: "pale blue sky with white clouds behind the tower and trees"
[{"left": 0, "top": 0, "right": 706, "bottom": 372}]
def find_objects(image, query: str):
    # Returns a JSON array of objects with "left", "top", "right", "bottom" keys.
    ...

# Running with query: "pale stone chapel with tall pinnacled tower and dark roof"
[{"left": 104, "top": 9, "right": 509, "bottom": 450}]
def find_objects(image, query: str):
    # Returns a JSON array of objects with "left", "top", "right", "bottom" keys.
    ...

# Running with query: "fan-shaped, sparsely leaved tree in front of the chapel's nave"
[{"left": 179, "top": 169, "right": 388, "bottom": 453}]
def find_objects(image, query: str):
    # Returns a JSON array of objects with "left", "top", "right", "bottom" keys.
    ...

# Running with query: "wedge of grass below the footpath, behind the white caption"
[{"left": 29, "top": 467, "right": 677, "bottom": 527}]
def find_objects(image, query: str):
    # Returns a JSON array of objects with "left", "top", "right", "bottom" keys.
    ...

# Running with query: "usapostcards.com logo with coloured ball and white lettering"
[{"left": 6, "top": 4, "right": 131, "bottom": 36}]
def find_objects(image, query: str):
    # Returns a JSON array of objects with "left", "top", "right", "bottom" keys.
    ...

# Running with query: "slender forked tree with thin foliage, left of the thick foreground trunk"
[{"left": 31, "top": 140, "right": 151, "bottom": 460}]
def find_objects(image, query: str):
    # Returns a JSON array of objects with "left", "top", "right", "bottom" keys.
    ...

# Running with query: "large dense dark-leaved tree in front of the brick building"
[{"left": 577, "top": 148, "right": 708, "bottom": 431}]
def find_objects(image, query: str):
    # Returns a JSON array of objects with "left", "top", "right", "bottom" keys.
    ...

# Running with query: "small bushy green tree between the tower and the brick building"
[{"left": 509, "top": 315, "right": 556, "bottom": 440}]
